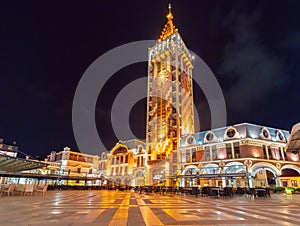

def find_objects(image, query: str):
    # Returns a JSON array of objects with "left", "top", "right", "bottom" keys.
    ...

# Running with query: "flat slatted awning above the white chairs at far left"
[{"left": 0, "top": 154, "right": 47, "bottom": 172}]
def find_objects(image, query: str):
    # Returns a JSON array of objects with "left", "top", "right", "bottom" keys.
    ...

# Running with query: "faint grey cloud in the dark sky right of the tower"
[{"left": 219, "top": 7, "right": 287, "bottom": 113}]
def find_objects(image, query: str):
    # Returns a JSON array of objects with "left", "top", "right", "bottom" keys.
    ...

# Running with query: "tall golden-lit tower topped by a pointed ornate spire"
[{"left": 146, "top": 5, "right": 194, "bottom": 164}]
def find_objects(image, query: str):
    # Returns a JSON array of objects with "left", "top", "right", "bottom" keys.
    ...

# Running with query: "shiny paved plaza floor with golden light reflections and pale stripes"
[{"left": 0, "top": 191, "right": 300, "bottom": 226}]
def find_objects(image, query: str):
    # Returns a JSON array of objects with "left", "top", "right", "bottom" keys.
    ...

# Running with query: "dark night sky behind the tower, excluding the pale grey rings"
[{"left": 0, "top": 0, "right": 300, "bottom": 158}]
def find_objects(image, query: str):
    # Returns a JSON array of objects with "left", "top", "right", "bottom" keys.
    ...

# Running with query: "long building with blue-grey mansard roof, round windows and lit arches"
[{"left": 178, "top": 123, "right": 300, "bottom": 187}]
